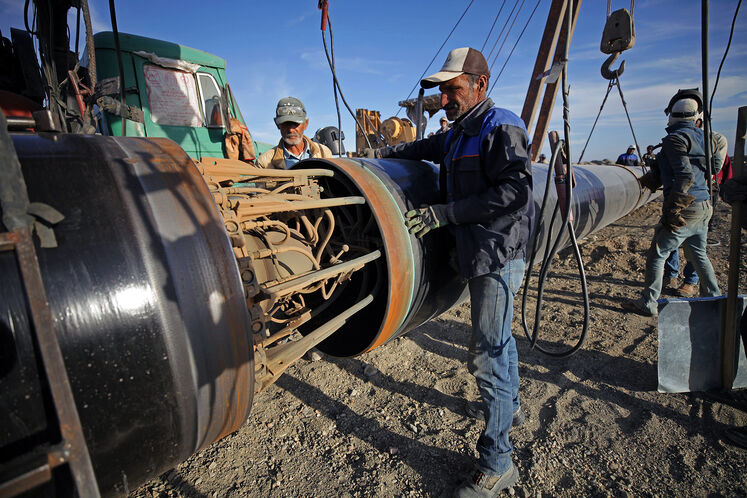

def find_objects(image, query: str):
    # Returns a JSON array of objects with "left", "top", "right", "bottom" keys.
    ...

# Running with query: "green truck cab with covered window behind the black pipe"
[{"left": 93, "top": 32, "right": 271, "bottom": 160}]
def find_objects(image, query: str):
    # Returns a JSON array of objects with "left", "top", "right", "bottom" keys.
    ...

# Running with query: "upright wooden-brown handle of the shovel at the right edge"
[{"left": 721, "top": 106, "right": 747, "bottom": 389}]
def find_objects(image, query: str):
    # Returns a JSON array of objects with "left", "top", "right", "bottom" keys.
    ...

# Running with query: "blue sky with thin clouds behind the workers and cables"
[{"left": 0, "top": 0, "right": 747, "bottom": 160}]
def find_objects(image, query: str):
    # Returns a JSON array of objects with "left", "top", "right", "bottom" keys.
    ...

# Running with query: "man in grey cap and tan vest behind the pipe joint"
[{"left": 257, "top": 97, "right": 332, "bottom": 169}]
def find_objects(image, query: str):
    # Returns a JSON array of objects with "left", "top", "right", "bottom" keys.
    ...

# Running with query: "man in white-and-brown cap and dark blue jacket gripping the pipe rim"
[{"left": 372, "top": 47, "right": 534, "bottom": 497}]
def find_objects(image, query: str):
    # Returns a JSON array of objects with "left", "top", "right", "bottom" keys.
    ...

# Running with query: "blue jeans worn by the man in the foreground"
[{"left": 468, "top": 259, "right": 525, "bottom": 475}]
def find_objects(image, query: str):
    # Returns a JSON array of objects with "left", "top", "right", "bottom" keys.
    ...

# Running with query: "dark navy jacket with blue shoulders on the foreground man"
[{"left": 380, "top": 99, "right": 534, "bottom": 279}]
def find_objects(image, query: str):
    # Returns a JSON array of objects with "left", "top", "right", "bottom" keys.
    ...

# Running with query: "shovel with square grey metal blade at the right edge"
[{"left": 657, "top": 106, "right": 747, "bottom": 392}]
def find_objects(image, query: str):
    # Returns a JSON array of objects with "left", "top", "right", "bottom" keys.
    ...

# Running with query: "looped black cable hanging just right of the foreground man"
[{"left": 522, "top": 2, "right": 589, "bottom": 358}]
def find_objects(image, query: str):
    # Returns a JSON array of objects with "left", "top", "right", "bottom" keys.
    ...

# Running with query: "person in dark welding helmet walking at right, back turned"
[{"left": 623, "top": 89, "right": 721, "bottom": 316}]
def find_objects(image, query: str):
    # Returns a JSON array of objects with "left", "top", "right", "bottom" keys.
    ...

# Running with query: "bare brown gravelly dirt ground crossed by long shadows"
[{"left": 132, "top": 196, "right": 747, "bottom": 497}]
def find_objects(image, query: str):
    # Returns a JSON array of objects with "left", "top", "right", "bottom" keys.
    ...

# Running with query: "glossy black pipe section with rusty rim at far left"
[{"left": 0, "top": 134, "right": 254, "bottom": 494}]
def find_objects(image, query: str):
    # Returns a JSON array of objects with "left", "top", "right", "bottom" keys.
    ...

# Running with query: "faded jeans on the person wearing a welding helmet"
[{"left": 641, "top": 201, "right": 721, "bottom": 313}]
